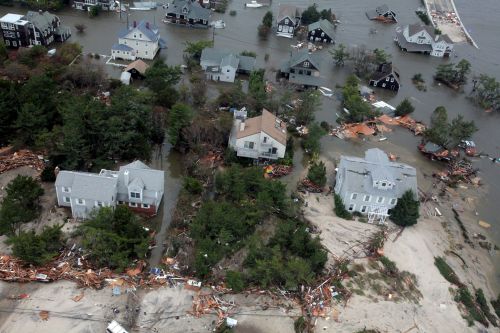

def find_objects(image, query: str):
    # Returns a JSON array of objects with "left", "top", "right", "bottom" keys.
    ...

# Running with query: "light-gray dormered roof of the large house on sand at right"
[{"left": 338, "top": 148, "right": 417, "bottom": 198}]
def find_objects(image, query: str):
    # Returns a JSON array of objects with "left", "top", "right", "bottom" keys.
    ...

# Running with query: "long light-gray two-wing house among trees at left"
[{"left": 55, "top": 161, "right": 164, "bottom": 219}]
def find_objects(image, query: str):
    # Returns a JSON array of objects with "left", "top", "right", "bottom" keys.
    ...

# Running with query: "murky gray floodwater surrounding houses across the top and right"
[{"left": 0, "top": 0, "right": 500, "bottom": 272}]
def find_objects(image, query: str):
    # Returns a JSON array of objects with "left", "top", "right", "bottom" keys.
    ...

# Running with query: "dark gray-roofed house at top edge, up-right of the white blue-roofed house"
[{"left": 165, "top": 0, "right": 211, "bottom": 29}]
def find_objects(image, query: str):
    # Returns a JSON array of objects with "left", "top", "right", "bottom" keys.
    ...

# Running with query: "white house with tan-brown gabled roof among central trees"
[{"left": 228, "top": 109, "right": 287, "bottom": 160}]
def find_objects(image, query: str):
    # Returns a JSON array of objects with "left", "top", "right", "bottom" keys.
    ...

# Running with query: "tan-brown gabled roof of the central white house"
[{"left": 236, "top": 109, "right": 286, "bottom": 145}]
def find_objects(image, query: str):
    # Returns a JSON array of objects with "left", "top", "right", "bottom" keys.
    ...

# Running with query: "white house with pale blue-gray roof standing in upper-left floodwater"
[{"left": 111, "top": 21, "right": 165, "bottom": 60}]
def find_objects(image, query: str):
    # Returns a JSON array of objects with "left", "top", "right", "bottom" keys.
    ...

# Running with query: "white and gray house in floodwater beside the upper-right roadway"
[{"left": 394, "top": 24, "right": 453, "bottom": 58}]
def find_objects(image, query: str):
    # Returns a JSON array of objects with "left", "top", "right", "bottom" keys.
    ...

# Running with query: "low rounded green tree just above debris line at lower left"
[{"left": 8, "top": 225, "right": 64, "bottom": 265}]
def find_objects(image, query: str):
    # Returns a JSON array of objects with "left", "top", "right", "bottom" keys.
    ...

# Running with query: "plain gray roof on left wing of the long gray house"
[{"left": 56, "top": 170, "right": 118, "bottom": 202}]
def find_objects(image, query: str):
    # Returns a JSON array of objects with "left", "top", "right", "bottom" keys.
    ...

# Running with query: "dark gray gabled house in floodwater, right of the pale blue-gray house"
[{"left": 278, "top": 49, "right": 321, "bottom": 89}]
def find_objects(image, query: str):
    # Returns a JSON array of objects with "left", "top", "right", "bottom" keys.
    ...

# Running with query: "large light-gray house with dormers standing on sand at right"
[{"left": 335, "top": 148, "right": 417, "bottom": 224}]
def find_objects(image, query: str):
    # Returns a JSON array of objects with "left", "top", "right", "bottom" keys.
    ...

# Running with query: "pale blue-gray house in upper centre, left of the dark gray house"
[{"left": 200, "top": 47, "right": 255, "bottom": 82}]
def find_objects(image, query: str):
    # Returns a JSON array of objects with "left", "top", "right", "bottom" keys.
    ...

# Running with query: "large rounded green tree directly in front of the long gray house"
[{"left": 78, "top": 205, "right": 149, "bottom": 270}]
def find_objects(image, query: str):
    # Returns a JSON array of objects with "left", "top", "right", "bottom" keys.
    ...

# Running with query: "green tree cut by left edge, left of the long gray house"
[{"left": 0, "top": 175, "right": 44, "bottom": 235}]
